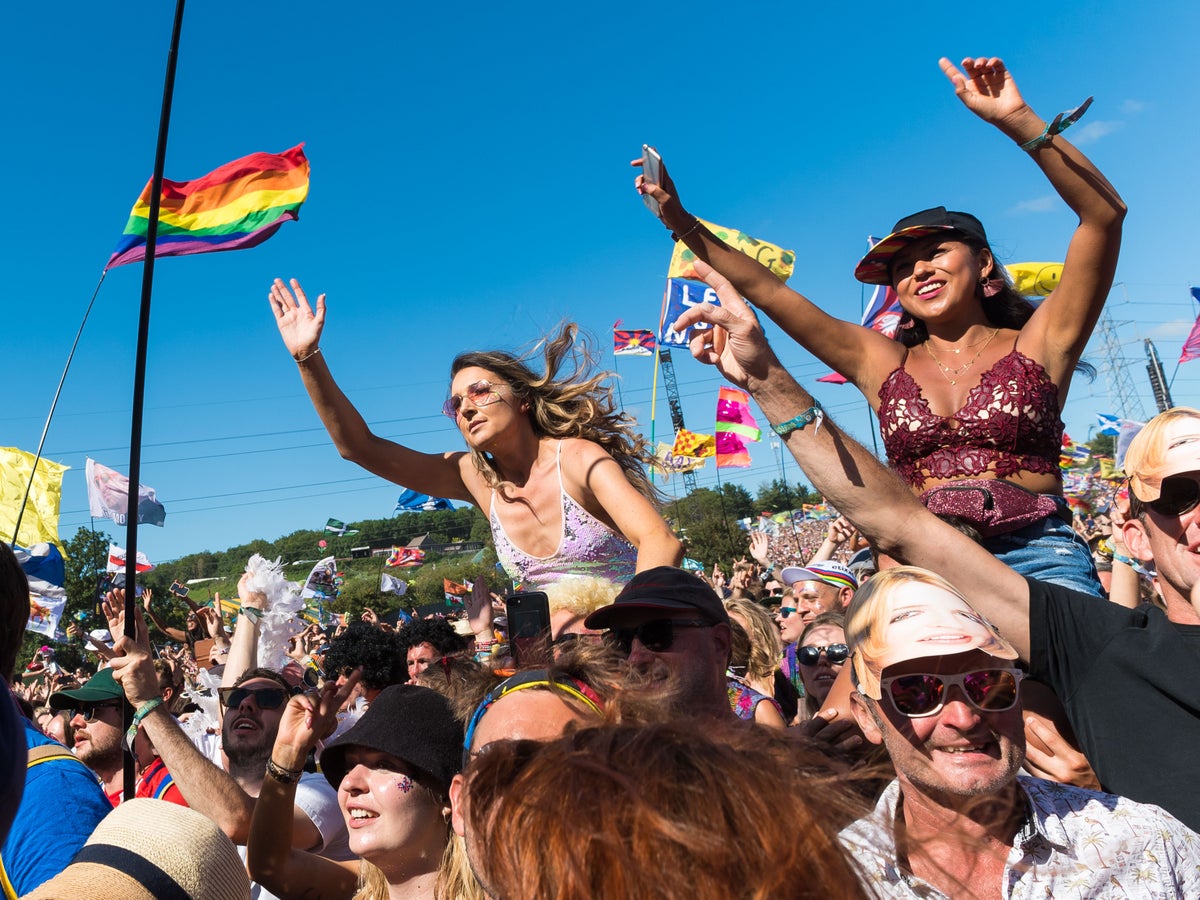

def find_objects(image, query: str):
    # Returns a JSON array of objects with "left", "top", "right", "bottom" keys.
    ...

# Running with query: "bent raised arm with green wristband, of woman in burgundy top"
[{"left": 938, "top": 56, "right": 1126, "bottom": 381}]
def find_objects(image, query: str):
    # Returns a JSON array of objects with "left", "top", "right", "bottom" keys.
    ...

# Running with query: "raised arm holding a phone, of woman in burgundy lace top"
[{"left": 632, "top": 160, "right": 904, "bottom": 401}]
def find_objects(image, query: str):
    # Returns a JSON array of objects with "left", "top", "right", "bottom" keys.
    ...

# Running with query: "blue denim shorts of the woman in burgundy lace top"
[{"left": 983, "top": 497, "right": 1105, "bottom": 598}]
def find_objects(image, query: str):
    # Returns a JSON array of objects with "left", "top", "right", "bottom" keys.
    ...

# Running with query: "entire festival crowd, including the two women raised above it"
[{"left": 0, "top": 58, "right": 1200, "bottom": 900}]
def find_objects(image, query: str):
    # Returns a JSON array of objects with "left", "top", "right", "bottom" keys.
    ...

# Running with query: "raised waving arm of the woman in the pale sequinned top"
[{"left": 270, "top": 278, "right": 473, "bottom": 500}]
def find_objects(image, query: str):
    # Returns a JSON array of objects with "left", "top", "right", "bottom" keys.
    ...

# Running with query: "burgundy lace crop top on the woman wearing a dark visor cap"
[{"left": 880, "top": 346, "right": 1063, "bottom": 487}]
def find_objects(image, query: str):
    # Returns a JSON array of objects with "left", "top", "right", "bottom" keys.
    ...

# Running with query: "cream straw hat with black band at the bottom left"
[{"left": 22, "top": 798, "right": 250, "bottom": 900}]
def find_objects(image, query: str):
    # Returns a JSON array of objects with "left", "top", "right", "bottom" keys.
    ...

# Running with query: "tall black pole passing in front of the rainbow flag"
[{"left": 125, "top": 0, "right": 184, "bottom": 800}]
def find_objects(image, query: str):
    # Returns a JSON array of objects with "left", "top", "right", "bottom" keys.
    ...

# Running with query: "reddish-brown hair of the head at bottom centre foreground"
[{"left": 467, "top": 720, "right": 868, "bottom": 900}]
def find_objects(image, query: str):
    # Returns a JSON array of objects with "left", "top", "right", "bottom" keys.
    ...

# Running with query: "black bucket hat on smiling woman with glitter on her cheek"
[{"left": 320, "top": 684, "right": 463, "bottom": 791}]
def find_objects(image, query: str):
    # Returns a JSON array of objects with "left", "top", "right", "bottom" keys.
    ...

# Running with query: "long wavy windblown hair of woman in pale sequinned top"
[{"left": 450, "top": 322, "right": 660, "bottom": 505}]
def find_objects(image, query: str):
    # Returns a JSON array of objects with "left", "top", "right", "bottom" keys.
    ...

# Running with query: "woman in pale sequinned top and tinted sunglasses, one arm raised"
[{"left": 270, "top": 278, "right": 683, "bottom": 589}]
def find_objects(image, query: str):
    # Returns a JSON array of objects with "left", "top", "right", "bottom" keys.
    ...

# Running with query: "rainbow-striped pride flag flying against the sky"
[{"left": 104, "top": 144, "right": 308, "bottom": 269}]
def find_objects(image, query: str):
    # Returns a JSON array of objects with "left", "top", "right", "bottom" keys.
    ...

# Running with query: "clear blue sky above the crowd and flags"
[{"left": 0, "top": 0, "right": 1200, "bottom": 559}]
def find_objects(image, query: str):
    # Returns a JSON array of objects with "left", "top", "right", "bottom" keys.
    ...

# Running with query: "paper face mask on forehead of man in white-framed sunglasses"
[{"left": 846, "top": 565, "right": 1018, "bottom": 700}]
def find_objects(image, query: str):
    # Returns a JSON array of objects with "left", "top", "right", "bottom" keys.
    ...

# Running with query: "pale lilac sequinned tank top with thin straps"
[{"left": 487, "top": 442, "right": 637, "bottom": 590}]
